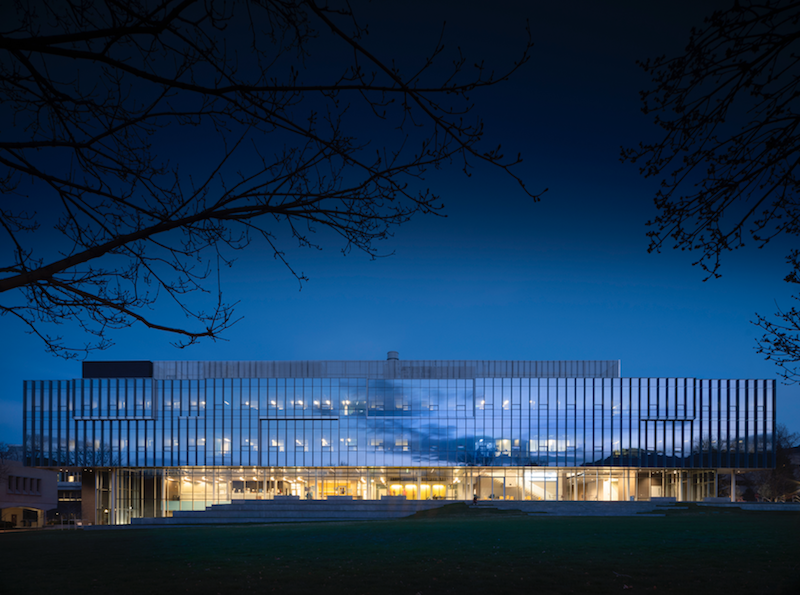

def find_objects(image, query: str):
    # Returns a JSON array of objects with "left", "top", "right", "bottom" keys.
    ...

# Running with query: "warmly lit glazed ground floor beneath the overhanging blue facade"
[{"left": 61, "top": 467, "right": 752, "bottom": 524}]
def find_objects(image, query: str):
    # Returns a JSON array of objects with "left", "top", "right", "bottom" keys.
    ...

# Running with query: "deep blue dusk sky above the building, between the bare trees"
[{"left": 0, "top": 1, "right": 800, "bottom": 444}]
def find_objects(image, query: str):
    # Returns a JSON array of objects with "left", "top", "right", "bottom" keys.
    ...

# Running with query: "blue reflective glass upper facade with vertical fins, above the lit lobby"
[{"left": 23, "top": 378, "right": 775, "bottom": 472}]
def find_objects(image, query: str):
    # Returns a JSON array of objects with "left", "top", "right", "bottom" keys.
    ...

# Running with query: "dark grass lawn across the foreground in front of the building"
[{"left": 0, "top": 504, "right": 800, "bottom": 595}]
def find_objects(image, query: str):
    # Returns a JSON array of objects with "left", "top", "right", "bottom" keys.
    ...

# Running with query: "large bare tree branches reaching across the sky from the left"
[{"left": 0, "top": 0, "right": 535, "bottom": 357}]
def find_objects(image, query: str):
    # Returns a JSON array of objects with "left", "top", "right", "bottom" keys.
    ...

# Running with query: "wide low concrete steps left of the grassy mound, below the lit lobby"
[{"left": 131, "top": 496, "right": 446, "bottom": 526}]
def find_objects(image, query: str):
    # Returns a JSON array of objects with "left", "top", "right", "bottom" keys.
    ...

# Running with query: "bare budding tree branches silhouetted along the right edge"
[{"left": 622, "top": 0, "right": 800, "bottom": 379}]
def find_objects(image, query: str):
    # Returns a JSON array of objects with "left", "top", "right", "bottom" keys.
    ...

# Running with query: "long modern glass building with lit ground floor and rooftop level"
[{"left": 23, "top": 352, "right": 775, "bottom": 523}]
